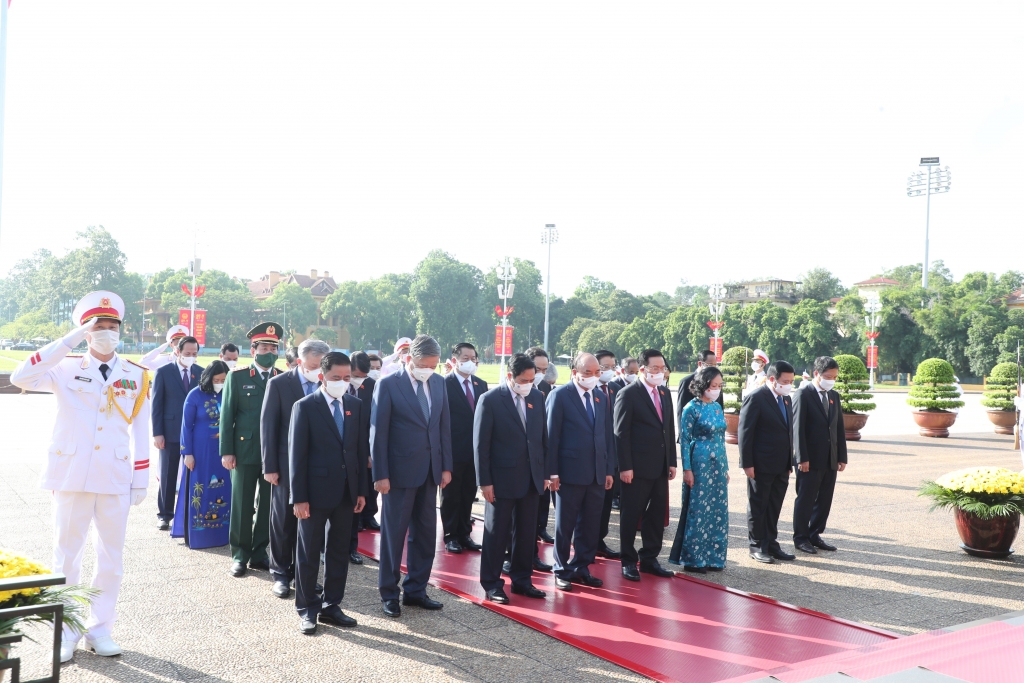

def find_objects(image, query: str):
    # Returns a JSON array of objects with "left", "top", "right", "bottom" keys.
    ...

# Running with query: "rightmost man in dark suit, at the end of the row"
[{"left": 793, "top": 355, "right": 847, "bottom": 554}]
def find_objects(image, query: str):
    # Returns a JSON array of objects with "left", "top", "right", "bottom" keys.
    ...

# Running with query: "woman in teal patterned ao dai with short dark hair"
[{"left": 679, "top": 367, "right": 729, "bottom": 573}]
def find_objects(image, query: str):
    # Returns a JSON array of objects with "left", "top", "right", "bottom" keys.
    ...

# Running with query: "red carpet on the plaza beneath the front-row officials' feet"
[{"left": 359, "top": 519, "right": 895, "bottom": 683}]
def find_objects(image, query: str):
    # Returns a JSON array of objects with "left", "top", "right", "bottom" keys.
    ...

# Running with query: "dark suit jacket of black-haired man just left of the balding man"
[{"left": 473, "top": 382, "right": 553, "bottom": 499}]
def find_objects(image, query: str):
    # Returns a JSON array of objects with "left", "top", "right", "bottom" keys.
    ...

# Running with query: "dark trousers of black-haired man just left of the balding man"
[{"left": 480, "top": 488, "right": 538, "bottom": 591}]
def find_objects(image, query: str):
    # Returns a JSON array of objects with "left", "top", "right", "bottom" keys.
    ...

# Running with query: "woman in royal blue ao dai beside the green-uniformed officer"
[{"left": 171, "top": 360, "right": 231, "bottom": 549}]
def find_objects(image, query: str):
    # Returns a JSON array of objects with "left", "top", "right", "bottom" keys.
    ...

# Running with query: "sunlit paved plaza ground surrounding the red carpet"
[{"left": 0, "top": 394, "right": 1024, "bottom": 683}]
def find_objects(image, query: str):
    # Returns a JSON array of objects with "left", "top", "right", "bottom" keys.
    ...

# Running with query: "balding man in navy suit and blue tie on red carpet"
[{"left": 547, "top": 353, "right": 614, "bottom": 591}]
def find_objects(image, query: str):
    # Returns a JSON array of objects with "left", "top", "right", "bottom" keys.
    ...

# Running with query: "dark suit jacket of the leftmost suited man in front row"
[{"left": 288, "top": 390, "right": 370, "bottom": 508}]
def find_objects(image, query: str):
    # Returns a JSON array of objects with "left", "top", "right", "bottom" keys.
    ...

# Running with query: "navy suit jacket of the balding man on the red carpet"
[{"left": 547, "top": 382, "right": 615, "bottom": 487}]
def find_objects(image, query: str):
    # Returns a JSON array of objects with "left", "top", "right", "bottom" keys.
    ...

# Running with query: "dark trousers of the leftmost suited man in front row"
[{"left": 295, "top": 484, "right": 355, "bottom": 622}]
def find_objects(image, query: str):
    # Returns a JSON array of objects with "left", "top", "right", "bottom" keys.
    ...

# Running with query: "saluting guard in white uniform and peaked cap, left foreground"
[{"left": 10, "top": 292, "right": 150, "bottom": 661}]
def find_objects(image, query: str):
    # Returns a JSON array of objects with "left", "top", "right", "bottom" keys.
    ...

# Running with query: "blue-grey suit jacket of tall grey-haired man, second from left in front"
[{"left": 370, "top": 369, "right": 452, "bottom": 488}]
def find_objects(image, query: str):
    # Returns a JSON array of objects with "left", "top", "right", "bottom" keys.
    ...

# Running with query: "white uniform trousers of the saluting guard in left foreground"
[{"left": 53, "top": 490, "right": 131, "bottom": 642}]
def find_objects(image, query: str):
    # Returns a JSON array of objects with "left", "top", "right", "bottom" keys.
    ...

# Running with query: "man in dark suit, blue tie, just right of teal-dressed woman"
[{"left": 737, "top": 360, "right": 797, "bottom": 564}]
